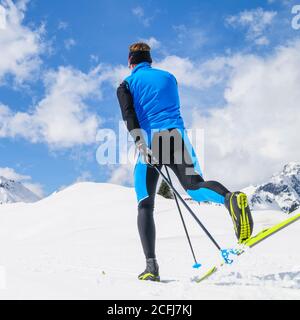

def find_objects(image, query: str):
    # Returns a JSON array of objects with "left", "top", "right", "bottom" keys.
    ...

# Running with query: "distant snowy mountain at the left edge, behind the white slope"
[{"left": 0, "top": 177, "right": 40, "bottom": 204}]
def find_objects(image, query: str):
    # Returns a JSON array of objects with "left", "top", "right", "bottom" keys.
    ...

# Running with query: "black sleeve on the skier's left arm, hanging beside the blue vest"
[{"left": 117, "top": 81, "right": 143, "bottom": 143}]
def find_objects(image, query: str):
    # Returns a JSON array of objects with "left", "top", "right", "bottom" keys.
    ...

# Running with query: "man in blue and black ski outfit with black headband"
[{"left": 117, "top": 42, "right": 253, "bottom": 281}]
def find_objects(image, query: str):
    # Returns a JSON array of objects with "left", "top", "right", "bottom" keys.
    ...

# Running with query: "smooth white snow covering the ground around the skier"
[{"left": 0, "top": 183, "right": 300, "bottom": 300}]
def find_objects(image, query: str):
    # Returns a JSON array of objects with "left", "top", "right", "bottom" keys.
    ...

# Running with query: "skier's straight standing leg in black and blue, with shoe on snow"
[{"left": 134, "top": 158, "right": 159, "bottom": 281}]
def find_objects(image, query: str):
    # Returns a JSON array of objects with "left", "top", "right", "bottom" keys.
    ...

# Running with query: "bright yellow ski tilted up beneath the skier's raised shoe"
[{"left": 194, "top": 214, "right": 300, "bottom": 283}]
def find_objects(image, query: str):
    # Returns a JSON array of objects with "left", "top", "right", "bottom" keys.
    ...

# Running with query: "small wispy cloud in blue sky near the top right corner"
[{"left": 226, "top": 8, "right": 277, "bottom": 45}]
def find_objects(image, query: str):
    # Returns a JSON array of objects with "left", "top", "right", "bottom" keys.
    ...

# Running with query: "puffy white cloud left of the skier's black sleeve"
[{"left": 34, "top": 67, "right": 100, "bottom": 147}]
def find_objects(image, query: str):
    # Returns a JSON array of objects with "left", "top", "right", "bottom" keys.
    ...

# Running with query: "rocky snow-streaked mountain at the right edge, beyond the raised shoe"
[{"left": 245, "top": 162, "right": 300, "bottom": 213}]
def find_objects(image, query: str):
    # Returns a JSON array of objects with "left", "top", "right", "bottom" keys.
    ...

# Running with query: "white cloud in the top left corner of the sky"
[{"left": 0, "top": 0, "right": 45, "bottom": 83}]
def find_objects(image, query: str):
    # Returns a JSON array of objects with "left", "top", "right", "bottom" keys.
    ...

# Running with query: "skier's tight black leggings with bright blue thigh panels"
[{"left": 135, "top": 130, "right": 229, "bottom": 259}]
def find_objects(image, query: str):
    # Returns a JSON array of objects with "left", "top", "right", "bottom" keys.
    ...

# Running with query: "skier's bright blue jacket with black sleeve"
[{"left": 118, "top": 62, "right": 184, "bottom": 142}]
